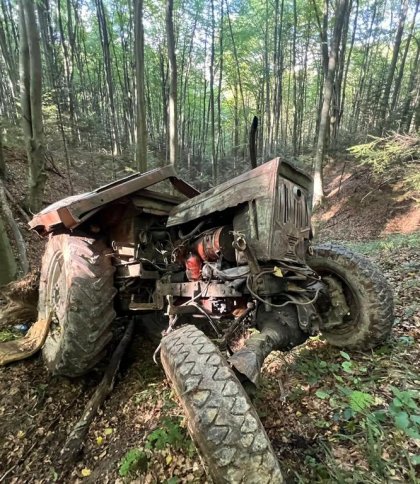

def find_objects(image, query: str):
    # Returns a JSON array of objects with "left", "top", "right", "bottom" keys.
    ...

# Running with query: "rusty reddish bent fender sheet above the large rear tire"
[{"left": 29, "top": 165, "right": 199, "bottom": 233}]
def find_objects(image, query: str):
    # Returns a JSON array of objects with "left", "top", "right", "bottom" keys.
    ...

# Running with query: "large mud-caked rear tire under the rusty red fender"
[{"left": 38, "top": 234, "right": 116, "bottom": 377}]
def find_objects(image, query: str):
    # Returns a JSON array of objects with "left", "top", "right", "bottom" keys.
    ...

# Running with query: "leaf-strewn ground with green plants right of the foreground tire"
[{"left": 257, "top": 233, "right": 420, "bottom": 484}]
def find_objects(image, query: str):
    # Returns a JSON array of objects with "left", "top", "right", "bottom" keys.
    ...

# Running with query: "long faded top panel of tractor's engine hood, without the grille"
[{"left": 167, "top": 158, "right": 312, "bottom": 227}]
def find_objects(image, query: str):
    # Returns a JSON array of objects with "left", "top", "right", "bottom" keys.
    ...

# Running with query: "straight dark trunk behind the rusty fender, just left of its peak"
[{"left": 134, "top": 0, "right": 147, "bottom": 173}]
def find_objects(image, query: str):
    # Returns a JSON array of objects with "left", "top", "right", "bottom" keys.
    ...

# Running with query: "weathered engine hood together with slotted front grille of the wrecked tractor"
[{"left": 168, "top": 158, "right": 312, "bottom": 264}]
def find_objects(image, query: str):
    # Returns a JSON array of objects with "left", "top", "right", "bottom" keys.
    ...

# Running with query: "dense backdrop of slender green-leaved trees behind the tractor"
[{"left": 0, "top": 0, "right": 420, "bottom": 193}]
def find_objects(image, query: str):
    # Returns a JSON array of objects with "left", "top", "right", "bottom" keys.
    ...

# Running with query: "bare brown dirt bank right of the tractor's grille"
[{"left": 314, "top": 161, "right": 420, "bottom": 240}]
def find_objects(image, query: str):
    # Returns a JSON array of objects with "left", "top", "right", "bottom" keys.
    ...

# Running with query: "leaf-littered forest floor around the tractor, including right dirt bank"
[{"left": 0, "top": 149, "right": 420, "bottom": 484}]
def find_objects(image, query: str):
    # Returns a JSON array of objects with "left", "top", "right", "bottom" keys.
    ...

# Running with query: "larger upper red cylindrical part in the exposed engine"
[{"left": 194, "top": 225, "right": 235, "bottom": 262}]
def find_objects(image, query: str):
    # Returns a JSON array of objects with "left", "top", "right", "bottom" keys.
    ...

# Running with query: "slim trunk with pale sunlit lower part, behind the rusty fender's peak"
[{"left": 166, "top": 0, "right": 178, "bottom": 166}]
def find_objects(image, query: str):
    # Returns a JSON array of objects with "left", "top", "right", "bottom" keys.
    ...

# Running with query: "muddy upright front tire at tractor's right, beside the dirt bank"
[{"left": 307, "top": 244, "right": 394, "bottom": 350}]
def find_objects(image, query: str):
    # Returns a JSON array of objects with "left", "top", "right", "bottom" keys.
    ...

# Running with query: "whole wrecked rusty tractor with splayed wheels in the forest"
[{"left": 30, "top": 158, "right": 393, "bottom": 482}]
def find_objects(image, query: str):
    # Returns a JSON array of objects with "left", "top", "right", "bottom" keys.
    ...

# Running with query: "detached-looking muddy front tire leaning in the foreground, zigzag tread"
[{"left": 161, "top": 326, "right": 283, "bottom": 483}]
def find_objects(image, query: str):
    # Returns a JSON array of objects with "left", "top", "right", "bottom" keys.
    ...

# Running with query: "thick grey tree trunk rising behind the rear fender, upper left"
[{"left": 19, "top": 0, "right": 47, "bottom": 213}]
